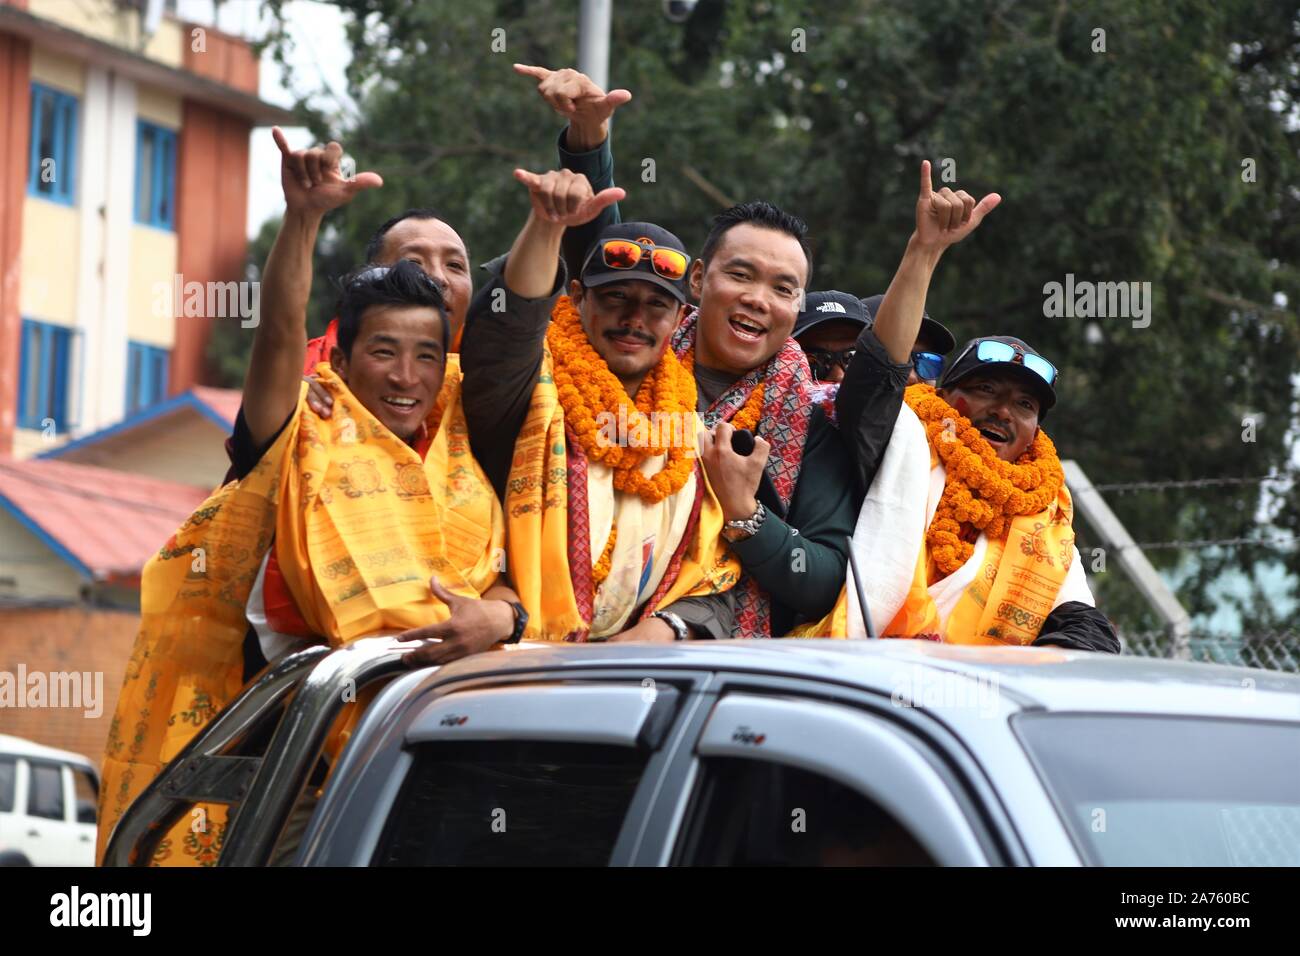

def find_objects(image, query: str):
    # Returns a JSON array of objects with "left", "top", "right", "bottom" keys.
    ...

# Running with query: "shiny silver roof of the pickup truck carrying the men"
[{"left": 439, "top": 639, "right": 1300, "bottom": 722}]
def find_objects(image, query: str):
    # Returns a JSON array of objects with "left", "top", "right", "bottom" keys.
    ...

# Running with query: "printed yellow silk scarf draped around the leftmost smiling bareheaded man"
[{"left": 99, "top": 355, "right": 504, "bottom": 866}]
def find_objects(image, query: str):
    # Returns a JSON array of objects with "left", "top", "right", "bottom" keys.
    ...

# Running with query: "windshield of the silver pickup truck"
[{"left": 1013, "top": 714, "right": 1300, "bottom": 866}]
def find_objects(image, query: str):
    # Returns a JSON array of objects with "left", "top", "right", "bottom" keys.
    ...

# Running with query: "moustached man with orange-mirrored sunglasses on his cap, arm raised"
[{"left": 462, "top": 169, "right": 740, "bottom": 641}]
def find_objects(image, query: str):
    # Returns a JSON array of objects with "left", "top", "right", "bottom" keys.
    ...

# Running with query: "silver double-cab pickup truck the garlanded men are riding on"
[{"left": 101, "top": 639, "right": 1300, "bottom": 866}]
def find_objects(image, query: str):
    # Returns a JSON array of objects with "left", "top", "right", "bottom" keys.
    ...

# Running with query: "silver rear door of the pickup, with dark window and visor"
[{"left": 299, "top": 674, "right": 712, "bottom": 866}]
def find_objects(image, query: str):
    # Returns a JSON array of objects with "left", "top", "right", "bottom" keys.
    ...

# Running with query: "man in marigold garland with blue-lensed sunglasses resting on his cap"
[{"left": 836, "top": 175, "right": 1119, "bottom": 653}]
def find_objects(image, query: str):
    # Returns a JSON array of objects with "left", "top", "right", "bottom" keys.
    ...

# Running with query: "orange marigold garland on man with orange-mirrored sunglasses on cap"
[{"left": 546, "top": 295, "right": 696, "bottom": 509}]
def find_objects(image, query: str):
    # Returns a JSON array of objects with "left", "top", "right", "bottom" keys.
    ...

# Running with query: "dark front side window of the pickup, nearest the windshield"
[{"left": 675, "top": 757, "right": 935, "bottom": 866}]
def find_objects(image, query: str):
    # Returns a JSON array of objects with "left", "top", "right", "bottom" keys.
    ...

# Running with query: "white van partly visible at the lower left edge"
[{"left": 0, "top": 734, "right": 99, "bottom": 866}]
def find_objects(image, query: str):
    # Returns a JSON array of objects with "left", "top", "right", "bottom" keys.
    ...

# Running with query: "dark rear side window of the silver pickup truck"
[{"left": 373, "top": 740, "right": 649, "bottom": 866}]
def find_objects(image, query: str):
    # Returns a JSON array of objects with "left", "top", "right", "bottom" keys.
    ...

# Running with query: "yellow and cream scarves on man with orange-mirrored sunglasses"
[{"left": 506, "top": 342, "right": 740, "bottom": 641}]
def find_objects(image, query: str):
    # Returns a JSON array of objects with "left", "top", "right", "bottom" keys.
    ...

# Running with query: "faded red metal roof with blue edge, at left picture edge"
[{"left": 0, "top": 455, "right": 208, "bottom": 580}]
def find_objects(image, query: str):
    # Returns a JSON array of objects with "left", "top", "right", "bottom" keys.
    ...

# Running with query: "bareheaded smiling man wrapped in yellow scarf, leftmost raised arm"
[{"left": 99, "top": 129, "right": 527, "bottom": 865}]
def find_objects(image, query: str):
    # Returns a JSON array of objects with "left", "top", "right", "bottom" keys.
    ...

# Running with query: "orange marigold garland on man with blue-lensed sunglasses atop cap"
[{"left": 904, "top": 384, "right": 1065, "bottom": 575}]
